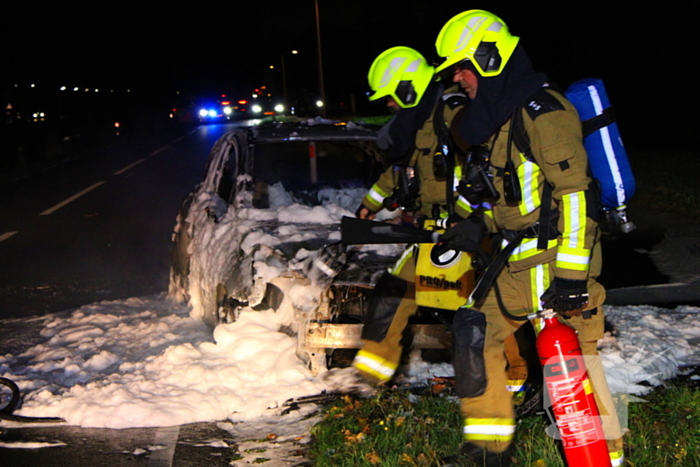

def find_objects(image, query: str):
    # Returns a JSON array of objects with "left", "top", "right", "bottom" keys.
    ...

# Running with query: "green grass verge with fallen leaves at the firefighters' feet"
[{"left": 309, "top": 385, "right": 700, "bottom": 467}]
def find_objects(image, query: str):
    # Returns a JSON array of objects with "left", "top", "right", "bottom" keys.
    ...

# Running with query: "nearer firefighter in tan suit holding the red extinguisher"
[{"left": 436, "top": 10, "right": 624, "bottom": 466}]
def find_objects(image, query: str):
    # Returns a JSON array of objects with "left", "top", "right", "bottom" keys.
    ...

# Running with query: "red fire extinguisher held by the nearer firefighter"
[{"left": 537, "top": 312, "right": 611, "bottom": 467}]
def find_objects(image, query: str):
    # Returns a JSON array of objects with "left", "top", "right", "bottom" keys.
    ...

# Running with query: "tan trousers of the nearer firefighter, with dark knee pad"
[{"left": 455, "top": 261, "right": 623, "bottom": 465}]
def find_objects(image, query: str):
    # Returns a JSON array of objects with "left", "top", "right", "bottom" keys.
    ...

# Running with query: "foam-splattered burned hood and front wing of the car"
[{"left": 183, "top": 186, "right": 401, "bottom": 318}]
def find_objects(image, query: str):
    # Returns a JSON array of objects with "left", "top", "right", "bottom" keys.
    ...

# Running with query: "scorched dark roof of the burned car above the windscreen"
[{"left": 252, "top": 119, "right": 379, "bottom": 143}]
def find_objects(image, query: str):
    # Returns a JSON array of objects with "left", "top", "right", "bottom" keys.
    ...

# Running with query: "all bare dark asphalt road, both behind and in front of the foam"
[{"left": 0, "top": 122, "right": 292, "bottom": 467}]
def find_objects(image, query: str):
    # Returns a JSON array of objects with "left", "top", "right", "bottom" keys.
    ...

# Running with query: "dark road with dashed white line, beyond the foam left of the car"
[{"left": 0, "top": 123, "right": 240, "bottom": 318}]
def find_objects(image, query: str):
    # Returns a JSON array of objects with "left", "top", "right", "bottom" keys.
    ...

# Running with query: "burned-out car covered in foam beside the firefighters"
[{"left": 169, "top": 119, "right": 454, "bottom": 372}]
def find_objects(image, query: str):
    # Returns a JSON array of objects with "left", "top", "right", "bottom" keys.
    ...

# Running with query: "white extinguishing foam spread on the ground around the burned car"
[{"left": 0, "top": 188, "right": 700, "bottom": 428}]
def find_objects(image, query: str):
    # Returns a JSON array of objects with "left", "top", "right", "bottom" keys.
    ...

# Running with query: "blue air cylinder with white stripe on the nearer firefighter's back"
[{"left": 564, "top": 78, "right": 636, "bottom": 233}]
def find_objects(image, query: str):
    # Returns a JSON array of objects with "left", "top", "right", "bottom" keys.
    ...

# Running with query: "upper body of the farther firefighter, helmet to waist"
[{"left": 357, "top": 47, "right": 470, "bottom": 223}]
